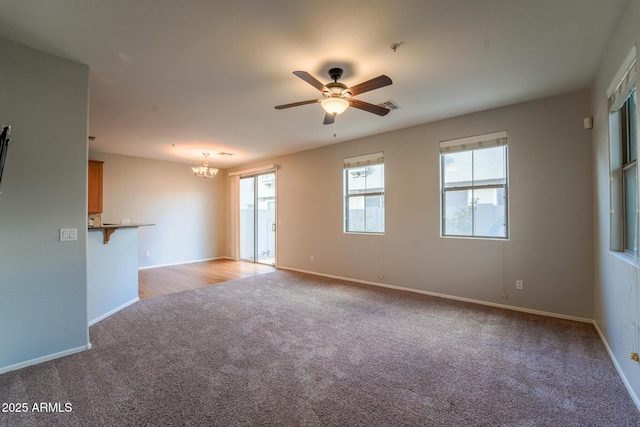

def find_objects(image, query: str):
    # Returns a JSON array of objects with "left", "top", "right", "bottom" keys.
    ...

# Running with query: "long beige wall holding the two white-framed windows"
[{"left": 228, "top": 91, "right": 593, "bottom": 319}]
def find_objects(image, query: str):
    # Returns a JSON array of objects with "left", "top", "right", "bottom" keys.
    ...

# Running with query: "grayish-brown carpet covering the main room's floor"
[{"left": 0, "top": 271, "right": 640, "bottom": 426}]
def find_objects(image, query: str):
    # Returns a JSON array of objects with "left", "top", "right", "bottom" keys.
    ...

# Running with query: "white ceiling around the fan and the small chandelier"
[{"left": 0, "top": 0, "right": 627, "bottom": 168}]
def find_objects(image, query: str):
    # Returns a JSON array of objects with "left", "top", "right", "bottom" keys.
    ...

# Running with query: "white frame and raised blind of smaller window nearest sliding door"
[{"left": 342, "top": 152, "right": 386, "bottom": 235}]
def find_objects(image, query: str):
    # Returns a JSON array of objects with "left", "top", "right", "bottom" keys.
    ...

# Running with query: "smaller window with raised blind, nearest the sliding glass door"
[{"left": 343, "top": 153, "right": 384, "bottom": 234}]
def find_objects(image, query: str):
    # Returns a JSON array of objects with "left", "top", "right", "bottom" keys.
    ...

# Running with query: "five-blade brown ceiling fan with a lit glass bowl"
[{"left": 275, "top": 68, "right": 393, "bottom": 125}]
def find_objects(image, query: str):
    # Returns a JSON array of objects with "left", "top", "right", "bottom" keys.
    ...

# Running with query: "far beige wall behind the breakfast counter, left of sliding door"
[{"left": 89, "top": 152, "right": 227, "bottom": 267}]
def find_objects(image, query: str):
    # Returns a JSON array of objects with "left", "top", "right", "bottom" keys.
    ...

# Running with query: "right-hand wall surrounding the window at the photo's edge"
[{"left": 592, "top": 0, "right": 640, "bottom": 407}]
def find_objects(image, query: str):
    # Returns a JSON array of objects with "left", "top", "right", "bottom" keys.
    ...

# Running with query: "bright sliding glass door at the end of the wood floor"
[{"left": 239, "top": 172, "right": 276, "bottom": 265}]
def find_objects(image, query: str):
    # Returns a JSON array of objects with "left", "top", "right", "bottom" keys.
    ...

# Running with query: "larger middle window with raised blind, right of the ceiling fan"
[{"left": 440, "top": 132, "right": 508, "bottom": 239}]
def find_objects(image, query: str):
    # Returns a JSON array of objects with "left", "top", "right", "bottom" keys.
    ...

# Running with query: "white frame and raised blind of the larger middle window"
[{"left": 440, "top": 131, "right": 509, "bottom": 240}]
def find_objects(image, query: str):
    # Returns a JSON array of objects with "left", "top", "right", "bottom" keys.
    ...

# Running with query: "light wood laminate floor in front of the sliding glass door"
[{"left": 138, "top": 259, "right": 275, "bottom": 299}]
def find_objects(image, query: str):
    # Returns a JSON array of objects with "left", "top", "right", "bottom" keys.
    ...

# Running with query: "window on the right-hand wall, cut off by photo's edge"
[{"left": 609, "top": 49, "right": 638, "bottom": 257}]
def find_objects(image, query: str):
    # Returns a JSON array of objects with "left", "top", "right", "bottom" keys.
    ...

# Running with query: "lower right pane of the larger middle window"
[{"left": 473, "top": 188, "right": 507, "bottom": 237}]
